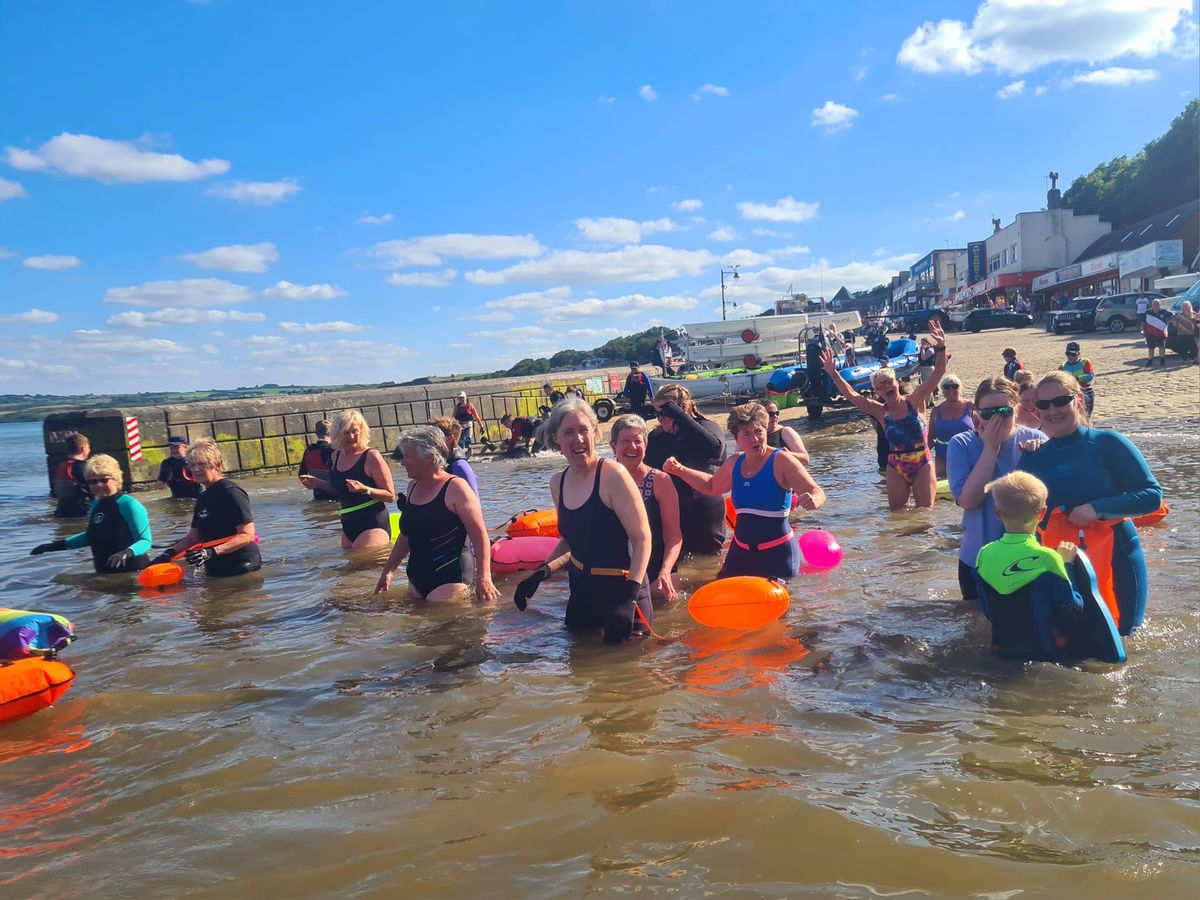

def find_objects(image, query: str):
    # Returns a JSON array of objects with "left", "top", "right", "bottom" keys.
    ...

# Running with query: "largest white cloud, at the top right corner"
[{"left": 896, "top": 0, "right": 1192, "bottom": 74}]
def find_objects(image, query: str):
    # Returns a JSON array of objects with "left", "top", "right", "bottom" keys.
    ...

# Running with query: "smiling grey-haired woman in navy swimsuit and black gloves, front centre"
[{"left": 512, "top": 397, "right": 654, "bottom": 643}]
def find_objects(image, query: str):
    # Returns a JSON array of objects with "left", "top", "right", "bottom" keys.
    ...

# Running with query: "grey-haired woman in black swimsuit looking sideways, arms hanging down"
[{"left": 374, "top": 425, "right": 500, "bottom": 602}]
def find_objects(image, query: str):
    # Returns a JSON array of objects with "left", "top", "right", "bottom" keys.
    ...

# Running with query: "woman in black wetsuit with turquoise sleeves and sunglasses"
[{"left": 31, "top": 454, "right": 151, "bottom": 572}]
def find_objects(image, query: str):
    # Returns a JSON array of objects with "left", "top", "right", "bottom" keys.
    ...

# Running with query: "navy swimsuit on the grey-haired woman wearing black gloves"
[{"left": 557, "top": 460, "right": 654, "bottom": 628}]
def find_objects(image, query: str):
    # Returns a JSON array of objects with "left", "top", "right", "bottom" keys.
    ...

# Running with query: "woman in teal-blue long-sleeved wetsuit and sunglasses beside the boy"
[{"left": 1020, "top": 372, "right": 1163, "bottom": 635}]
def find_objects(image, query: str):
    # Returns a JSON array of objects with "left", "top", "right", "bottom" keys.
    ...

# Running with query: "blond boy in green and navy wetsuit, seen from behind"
[{"left": 976, "top": 472, "right": 1084, "bottom": 661}]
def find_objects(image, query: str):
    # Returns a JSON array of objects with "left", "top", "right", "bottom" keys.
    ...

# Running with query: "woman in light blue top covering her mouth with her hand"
[{"left": 946, "top": 378, "right": 1046, "bottom": 600}]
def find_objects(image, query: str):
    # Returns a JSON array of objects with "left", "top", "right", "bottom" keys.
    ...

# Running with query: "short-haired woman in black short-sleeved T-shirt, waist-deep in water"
[{"left": 152, "top": 438, "right": 263, "bottom": 578}]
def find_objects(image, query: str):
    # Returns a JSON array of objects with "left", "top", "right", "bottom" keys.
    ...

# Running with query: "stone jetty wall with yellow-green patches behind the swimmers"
[{"left": 42, "top": 366, "right": 658, "bottom": 491}]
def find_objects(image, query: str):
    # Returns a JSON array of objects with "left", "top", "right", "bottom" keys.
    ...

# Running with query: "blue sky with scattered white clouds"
[{"left": 0, "top": 0, "right": 1200, "bottom": 394}]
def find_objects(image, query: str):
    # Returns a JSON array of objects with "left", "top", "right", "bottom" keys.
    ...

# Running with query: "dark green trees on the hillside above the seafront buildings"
[{"left": 1062, "top": 100, "right": 1200, "bottom": 228}]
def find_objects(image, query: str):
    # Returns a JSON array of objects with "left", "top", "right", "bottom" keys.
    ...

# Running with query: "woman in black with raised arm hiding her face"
[{"left": 646, "top": 384, "right": 725, "bottom": 553}]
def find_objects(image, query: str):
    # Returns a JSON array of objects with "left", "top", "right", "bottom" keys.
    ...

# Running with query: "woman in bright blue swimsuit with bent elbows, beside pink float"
[{"left": 662, "top": 402, "right": 826, "bottom": 581}]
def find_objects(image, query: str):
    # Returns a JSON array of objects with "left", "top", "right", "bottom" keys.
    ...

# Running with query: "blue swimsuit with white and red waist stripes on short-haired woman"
[{"left": 718, "top": 449, "right": 800, "bottom": 581}]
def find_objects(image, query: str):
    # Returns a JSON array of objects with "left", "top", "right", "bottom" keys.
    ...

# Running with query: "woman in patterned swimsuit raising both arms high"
[{"left": 821, "top": 319, "right": 946, "bottom": 512}]
